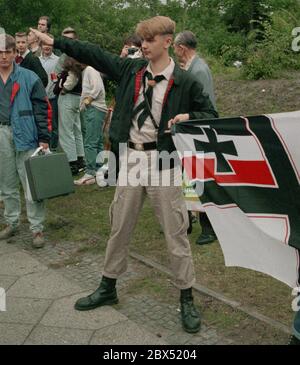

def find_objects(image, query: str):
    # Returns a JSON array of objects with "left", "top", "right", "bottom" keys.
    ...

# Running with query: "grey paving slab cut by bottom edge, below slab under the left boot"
[{"left": 24, "top": 325, "right": 94, "bottom": 345}]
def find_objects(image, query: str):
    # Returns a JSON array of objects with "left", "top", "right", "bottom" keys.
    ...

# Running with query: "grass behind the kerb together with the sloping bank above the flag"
[{"left": 47, "top": 70, "right": 300, "bottom": 325}]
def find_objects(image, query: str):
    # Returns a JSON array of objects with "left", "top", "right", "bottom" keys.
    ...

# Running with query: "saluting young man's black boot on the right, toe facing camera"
[{"left": 180, "top": 288, "right": 201, "bottom": 333}]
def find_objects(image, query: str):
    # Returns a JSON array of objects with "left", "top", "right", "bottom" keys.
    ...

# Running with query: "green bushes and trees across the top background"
[{"left": 0, "top": 0, "right": 300, "bottom": 79}]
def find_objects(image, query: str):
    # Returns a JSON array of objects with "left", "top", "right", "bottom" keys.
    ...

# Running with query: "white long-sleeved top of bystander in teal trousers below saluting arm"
[{"left": 80, "top": 66, "right": 107, "bottom": 112}]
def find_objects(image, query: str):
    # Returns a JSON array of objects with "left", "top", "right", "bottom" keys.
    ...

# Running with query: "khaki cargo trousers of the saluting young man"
[{"left": 103, "top": 149, "right": 195, "bottom": 289}]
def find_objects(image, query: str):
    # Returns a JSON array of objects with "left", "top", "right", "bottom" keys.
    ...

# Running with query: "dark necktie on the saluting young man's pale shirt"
[{"left": 133, "top": 71, "right": 165, "bottom": 129}]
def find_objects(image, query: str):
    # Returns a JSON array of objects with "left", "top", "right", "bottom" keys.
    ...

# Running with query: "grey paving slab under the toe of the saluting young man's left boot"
[{"left": 41, "top": 293, "right": 127, "bottom": 330}]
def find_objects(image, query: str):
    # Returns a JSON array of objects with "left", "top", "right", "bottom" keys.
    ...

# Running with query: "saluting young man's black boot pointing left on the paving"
[{"left": 75, "top": 276, "right": 119, "bottom": 311}]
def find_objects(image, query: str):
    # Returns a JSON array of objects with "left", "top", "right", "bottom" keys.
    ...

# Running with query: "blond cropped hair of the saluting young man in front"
[{"left": 136, "top": 15, "right": 176, "bottom": 39}]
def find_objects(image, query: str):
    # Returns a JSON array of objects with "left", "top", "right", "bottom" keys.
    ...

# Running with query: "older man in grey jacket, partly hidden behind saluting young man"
[{"left": 174, "top": 30, "right": 217, "bottom": 245}]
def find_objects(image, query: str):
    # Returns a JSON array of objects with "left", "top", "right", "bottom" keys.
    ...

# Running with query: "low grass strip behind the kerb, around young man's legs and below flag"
[{"left": 47, "top": 186, "right": 293, "bottom": 325}]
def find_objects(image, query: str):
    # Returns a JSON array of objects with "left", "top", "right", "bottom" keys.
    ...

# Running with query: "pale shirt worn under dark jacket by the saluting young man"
[{"left": 130, "top": 58, "right": 175, "bottom": 143}]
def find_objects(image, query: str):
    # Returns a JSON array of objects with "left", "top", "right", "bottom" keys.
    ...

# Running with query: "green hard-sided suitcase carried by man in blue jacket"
[{"left": 25, "top": 152, "right": 75, "bottom": 201}]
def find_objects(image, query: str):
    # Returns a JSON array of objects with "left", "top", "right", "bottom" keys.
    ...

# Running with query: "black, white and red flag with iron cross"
[{"left": 173, "top": 111, "right": 300, "bottom": 287}]
